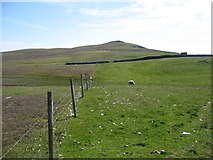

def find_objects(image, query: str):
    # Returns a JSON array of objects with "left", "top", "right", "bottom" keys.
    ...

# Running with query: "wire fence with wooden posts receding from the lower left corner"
[{"left": 0, "top": 73, "right": 94, "bottom": 160}]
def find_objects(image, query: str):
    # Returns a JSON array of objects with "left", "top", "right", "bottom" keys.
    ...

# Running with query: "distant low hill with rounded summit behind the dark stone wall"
[{"left": 2, "top": 41, "right": 178, "bottom": 62}]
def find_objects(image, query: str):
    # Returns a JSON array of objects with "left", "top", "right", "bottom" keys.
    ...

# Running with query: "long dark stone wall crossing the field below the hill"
[{"left": 65, "top": 54, "right": 213, "bottom": 65}]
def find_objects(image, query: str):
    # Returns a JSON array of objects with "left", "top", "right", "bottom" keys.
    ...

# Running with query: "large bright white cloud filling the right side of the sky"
[{"left": 81, "top": 0, "right": 211, "bottom": 54}]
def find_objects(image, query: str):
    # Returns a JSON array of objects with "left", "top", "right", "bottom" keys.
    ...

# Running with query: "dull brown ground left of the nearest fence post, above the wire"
[{"left": 2, "top": 95, "right": 47, "bottom": 153}]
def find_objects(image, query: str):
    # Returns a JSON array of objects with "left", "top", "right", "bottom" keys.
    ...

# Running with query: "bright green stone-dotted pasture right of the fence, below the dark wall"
[{"left": 58, "top": 58, "right": 211, "bottom": 158}]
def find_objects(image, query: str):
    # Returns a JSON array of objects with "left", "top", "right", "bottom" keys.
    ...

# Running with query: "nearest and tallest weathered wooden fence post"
[{"left": 47, "top": 92, "right": 54, "bottom": 160}]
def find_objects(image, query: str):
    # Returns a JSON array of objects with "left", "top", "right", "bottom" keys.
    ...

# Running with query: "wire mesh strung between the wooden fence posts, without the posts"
[{"left": 0, "top": 74, "right": 92, "bottom": 159}]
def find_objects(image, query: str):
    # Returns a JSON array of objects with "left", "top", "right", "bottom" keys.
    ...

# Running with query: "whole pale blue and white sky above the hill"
[{"left": 0, "top": 0, "right": 211, "bottom": 54}]
